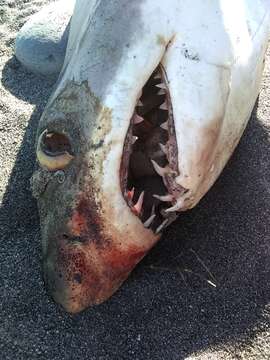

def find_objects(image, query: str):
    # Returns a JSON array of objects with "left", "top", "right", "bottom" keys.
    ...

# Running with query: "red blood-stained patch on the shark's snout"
[{"left": 58, "top": 198, "right": 147, "bottom": 305}]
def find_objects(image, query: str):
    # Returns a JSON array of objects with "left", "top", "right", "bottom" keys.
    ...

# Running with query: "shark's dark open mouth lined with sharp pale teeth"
[{"left": 120, "top": 65, "right": 188, "bottom": 234}]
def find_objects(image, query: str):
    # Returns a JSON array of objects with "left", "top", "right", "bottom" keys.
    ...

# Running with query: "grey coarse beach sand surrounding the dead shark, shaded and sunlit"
[{"left": 0, "top": 0, "right": 270, "bottom": 360}]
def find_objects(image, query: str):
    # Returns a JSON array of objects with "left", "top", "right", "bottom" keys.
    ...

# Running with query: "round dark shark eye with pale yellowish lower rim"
[{"left": 37, "top": 130, "right": 74, "bottom": 171}]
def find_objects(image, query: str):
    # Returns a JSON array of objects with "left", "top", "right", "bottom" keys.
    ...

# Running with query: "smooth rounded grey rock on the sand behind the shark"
[{"left": 15, "top": 0, "right": 75, "bottom": 76}]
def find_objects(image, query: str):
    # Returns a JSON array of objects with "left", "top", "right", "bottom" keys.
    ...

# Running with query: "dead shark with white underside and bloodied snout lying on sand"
[{"left": 17, "top": 0, "right": 270, "bottom": 313}]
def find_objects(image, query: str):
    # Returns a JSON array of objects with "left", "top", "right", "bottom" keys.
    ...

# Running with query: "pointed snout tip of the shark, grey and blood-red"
[{"left": 43, "top": 203, "right": 151, "bottom": 313}]
